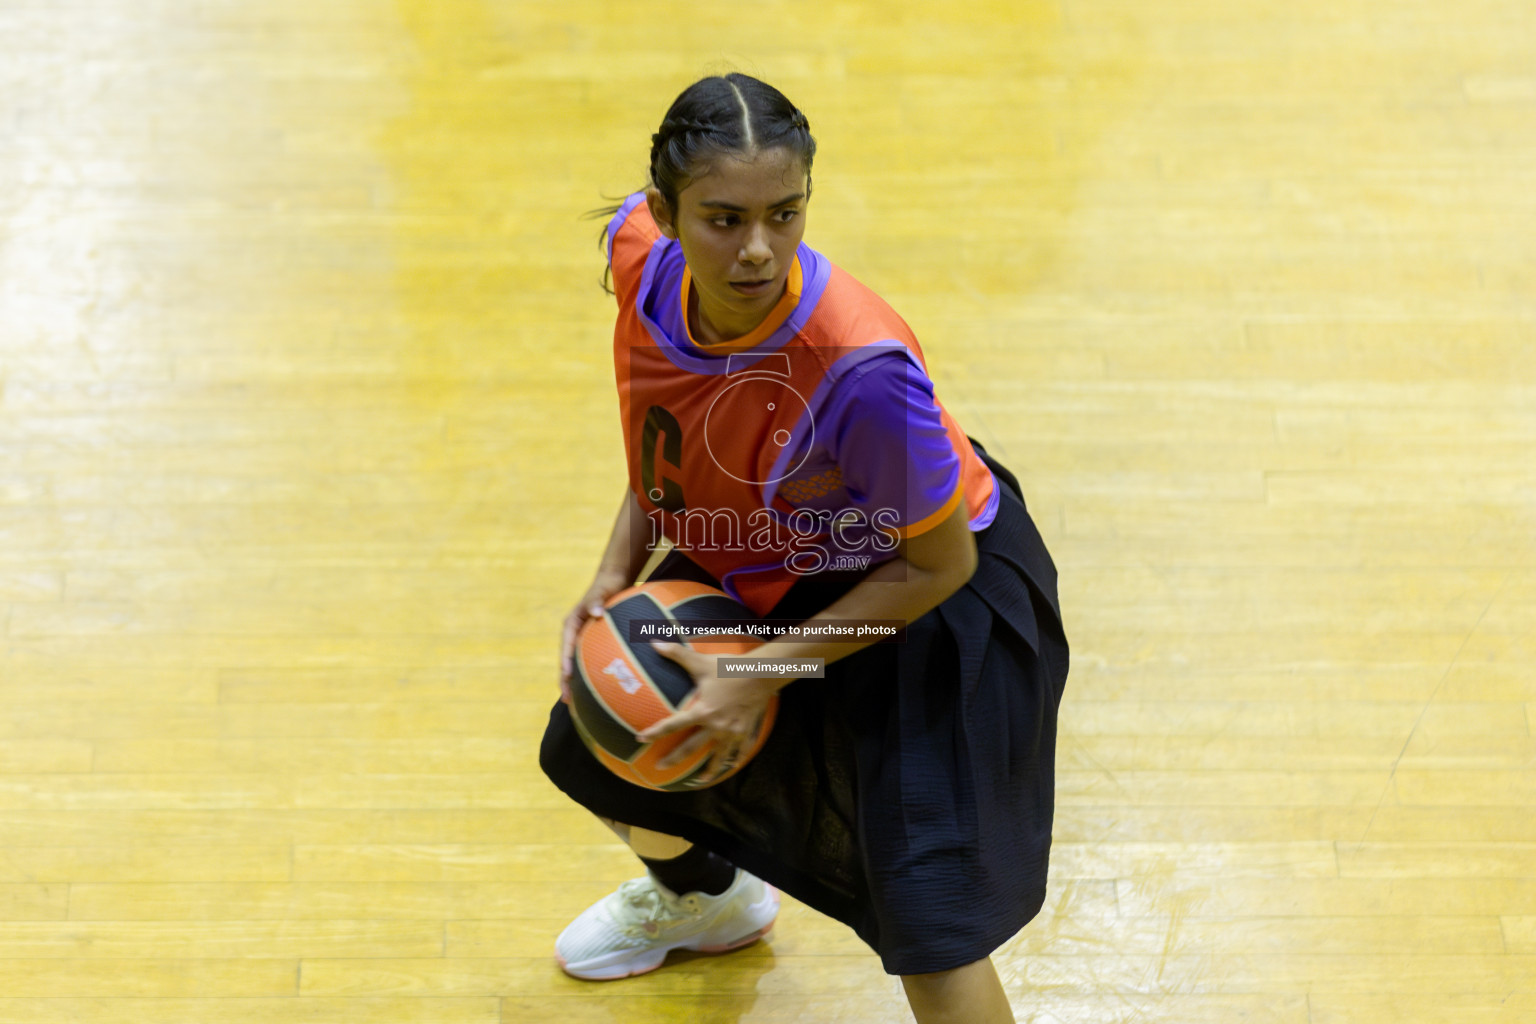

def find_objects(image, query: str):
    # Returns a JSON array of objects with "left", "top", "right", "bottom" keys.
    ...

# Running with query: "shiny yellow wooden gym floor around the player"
[{"left": 0, "top": 0, "right": 1536, "bottom": 1024}]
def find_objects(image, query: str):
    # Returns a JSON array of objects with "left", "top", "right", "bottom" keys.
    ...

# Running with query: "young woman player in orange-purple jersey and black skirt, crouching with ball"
[{"left": 541, "top": 74, "right": 1068, "bottom": 1024}]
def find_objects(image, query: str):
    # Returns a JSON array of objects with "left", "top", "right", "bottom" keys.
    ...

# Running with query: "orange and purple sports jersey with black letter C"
[{"left": 608, "top": 193, "right": 998, "bottom": 614}]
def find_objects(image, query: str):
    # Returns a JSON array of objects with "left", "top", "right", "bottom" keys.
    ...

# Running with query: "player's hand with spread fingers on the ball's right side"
[{"left": 636, "top": 642, "right": 777, "bottom": 786}]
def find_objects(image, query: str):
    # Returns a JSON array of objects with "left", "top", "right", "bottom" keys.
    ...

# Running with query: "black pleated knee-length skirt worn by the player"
[{"left": 539, "top": 447, "right": 1068, "bottom": 975}]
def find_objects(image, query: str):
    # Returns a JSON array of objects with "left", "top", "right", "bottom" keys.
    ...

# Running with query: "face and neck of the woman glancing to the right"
[{"left": 647, "top": 147, "right": 809, "bottom": 341}]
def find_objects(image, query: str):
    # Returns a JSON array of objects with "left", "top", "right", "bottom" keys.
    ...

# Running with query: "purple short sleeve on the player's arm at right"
[{"left": 817, "top": 353, "right": 960, "bottom": 534}]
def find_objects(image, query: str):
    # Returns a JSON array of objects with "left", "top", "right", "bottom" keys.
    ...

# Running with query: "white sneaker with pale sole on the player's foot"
[{"left": 554, "top": 869, "right": 779, "bottom": 981}]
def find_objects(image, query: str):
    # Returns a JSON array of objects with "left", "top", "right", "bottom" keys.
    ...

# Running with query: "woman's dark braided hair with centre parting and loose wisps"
[{"left": 591, "top": 72, "right": 816, "bottom": 292}]
